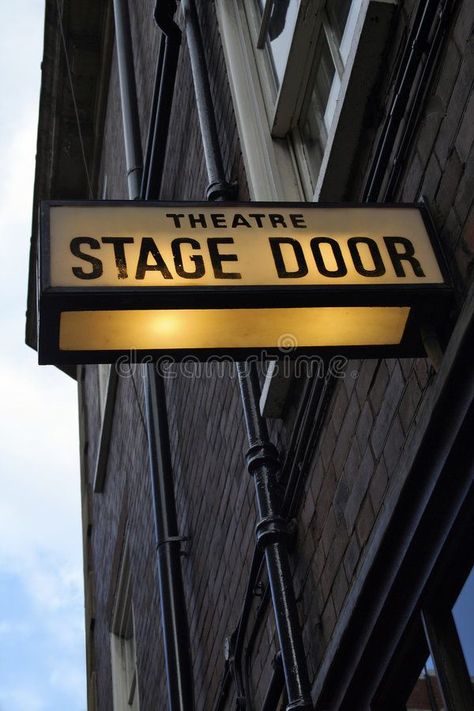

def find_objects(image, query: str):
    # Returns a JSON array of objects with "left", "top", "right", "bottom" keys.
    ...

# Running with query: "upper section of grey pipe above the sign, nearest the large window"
[{"left": 181, "top": 0, "right": 234, "bottom": 200}]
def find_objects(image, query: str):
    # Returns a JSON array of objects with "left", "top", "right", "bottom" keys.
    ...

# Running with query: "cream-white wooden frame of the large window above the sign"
[{"left": 216, "top": 0, "right": 398, "bottom": 201}]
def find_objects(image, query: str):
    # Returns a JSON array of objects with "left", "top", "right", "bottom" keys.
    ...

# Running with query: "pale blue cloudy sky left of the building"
[{"left": 0, "top": 0, "right": 86, "bottom": 711}]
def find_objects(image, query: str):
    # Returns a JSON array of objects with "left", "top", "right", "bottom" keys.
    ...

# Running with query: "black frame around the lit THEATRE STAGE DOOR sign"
[{"left": 38, "top": 200, "right": 453, "bottom": 365}]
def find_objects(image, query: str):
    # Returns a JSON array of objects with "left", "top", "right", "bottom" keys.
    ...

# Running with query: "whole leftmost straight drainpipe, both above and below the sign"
[{"left": 114, "top": 0, "right": 194, "bottom": 711}]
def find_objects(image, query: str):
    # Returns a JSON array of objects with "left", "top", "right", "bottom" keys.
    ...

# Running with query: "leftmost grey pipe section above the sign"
[{"left": 114, "top": 0, "right": 143, "bottom": 200}]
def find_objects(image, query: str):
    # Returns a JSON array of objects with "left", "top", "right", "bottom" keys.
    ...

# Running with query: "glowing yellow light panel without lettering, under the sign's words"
[{"left": 59, "top": 306, "right": 410, "bottom": 351}]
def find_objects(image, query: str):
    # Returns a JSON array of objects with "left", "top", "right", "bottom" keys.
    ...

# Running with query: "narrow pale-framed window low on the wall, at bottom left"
[{"left": 110, "top": 548, "right": 140, "bottom": 711}]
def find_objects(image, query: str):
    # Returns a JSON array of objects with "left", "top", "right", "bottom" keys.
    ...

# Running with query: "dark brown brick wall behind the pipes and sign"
[{"left": 82, "top": 0, "right": 474, "bottom": 711}]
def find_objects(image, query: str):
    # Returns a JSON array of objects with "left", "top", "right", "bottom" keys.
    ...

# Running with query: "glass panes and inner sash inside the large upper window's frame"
[{"left": 255, "top": 0, "right": 361, "bottom": 188}]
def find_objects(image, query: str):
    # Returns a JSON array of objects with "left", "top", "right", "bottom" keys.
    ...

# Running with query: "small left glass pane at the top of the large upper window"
[{"left": 258, "top": 0, "right": 300, "bottom": 85}]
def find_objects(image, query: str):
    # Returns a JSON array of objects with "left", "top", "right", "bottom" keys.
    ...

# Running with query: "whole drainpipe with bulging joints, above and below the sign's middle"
[{"left": 182, "top": 0, "right": 313, "bottom": 711}]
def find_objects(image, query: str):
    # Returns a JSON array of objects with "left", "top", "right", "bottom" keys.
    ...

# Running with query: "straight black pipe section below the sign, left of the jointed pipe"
[{"left": 145, "top": 366, "right": 194, "bottom": 711}]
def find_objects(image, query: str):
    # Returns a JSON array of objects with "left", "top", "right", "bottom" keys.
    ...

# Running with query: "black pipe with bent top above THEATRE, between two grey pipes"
[{"left": 142, "top": 0, "right": 181, "bottom": 200}]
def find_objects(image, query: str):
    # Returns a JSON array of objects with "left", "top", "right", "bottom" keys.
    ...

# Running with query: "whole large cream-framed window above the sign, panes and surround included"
[{"left": 216, "top": 0, "right": 396, "bottom": 200}]
